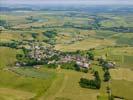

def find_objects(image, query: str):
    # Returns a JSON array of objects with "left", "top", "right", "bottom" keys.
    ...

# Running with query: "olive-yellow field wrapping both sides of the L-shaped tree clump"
[{"left": 40, "top": 66, "right": 114, "bottom": 100}]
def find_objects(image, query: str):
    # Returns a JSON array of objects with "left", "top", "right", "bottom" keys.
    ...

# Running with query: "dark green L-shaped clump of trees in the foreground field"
[{"left": 79, "top": 71, "right": 101, "bottom": 89}]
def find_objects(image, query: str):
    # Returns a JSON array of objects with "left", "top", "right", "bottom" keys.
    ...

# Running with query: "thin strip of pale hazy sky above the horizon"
[{"left": 0, "top": 0, "right": 133, "bottom": 5}]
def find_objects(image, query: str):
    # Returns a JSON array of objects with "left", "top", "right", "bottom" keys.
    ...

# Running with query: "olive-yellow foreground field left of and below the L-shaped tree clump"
[{"left": 40, "top": 69, "right": 99, "bottom": 100}]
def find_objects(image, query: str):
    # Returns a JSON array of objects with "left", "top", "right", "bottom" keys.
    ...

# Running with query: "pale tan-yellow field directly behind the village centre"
[{"left": 55, "top": 38, "right": 115, "bottom": 51}]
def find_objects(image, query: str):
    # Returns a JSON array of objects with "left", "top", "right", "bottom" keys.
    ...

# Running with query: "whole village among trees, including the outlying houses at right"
[{"left": 16, "top": 43, "right": 116, "bottom": 69}]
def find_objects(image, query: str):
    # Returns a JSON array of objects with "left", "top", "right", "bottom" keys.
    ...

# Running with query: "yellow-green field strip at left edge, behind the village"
[{"left": 0, "top": 30, "right": 46, "bottom": 42}]
